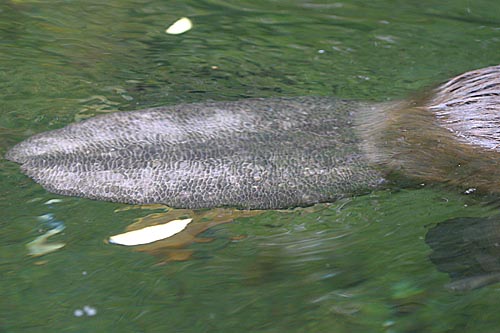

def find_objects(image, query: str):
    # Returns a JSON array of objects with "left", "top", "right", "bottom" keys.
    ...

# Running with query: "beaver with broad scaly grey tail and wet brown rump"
[{"left": 6, "top": 65, "right": 500, "bottom": 209}]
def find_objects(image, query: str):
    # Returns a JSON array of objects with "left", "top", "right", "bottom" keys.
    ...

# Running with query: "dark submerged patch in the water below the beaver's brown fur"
[{"left": 425, "top": 215, "right": 500, "bottom": 291}]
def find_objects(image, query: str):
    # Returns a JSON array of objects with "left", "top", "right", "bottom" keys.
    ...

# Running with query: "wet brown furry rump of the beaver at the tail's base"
[{"left": 358, "top": 66, "right": 500, "bottom": 193}]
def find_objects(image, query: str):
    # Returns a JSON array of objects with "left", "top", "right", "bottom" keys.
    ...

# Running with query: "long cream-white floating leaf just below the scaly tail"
[{"left": 109, "top": 219, "right": 193, "bottom": 246}]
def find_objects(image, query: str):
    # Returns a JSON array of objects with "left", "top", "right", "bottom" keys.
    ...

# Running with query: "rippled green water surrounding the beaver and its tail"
[{"left": 0, "top": 0, "right": 500, "bottom": 332}]
